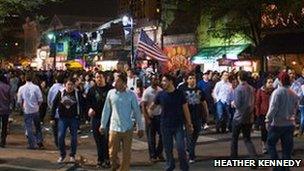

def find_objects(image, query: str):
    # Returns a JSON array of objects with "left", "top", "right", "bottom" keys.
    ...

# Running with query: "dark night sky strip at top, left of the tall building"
[{"left": 42, "top": 0, "right": 118, "bottom": 17}]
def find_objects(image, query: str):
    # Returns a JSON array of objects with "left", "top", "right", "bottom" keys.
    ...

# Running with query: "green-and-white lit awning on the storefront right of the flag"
[{"left": 191, "top": 44, "right": 250, "bottom": 63}]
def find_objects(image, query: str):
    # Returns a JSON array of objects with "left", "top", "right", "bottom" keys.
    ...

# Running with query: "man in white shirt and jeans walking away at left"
[{"left": 18, "top": 73, "right": 43, "bottom": 149}]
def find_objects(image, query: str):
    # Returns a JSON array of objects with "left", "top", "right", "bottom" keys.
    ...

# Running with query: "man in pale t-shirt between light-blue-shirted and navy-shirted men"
[{"left": 141, "top": 75, "right": 163, "bottom": 162}]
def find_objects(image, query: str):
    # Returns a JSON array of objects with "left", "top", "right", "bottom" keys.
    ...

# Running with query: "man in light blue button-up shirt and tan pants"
[{"left": 99, "top": 74, "right": 144, "bottom": 171}]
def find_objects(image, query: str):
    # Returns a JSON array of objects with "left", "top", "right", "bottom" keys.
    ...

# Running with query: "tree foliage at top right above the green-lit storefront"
[{"left": 198, "top": 0, "right": 304, "bottom": 45}]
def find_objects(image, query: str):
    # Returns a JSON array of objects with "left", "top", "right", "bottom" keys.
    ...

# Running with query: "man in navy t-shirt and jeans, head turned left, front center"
[{"left": 150, "top": 75, "right": 193, "bottom": 171}]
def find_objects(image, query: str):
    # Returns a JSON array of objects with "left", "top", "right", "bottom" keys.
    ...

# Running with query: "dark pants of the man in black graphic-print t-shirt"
[{"left": 187, "top": 120, "right": 202, "bottom": 160}]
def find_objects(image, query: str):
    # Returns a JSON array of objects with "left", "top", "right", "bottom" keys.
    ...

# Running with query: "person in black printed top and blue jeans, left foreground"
[{"left": 52, "top": 78, "right": 83, "bottom": 163}]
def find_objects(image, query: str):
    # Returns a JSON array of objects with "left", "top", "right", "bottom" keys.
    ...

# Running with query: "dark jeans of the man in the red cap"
[{"left": 267, "top": 126, "right": 295, "bottom": 170}]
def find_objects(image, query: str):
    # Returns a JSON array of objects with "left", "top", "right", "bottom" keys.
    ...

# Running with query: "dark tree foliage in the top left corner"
[{"left": 0, "top": 0, "right": 63, "bottom": 58}]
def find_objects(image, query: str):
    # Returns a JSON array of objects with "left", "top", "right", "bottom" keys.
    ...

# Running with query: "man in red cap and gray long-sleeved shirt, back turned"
[{"left": 265, "top": 72, "right": 299, "bottom": 170}]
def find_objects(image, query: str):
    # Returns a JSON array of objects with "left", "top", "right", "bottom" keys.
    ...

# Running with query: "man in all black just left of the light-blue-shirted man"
[{"left": 87, "top": 72, "right": 113, "bottom": 168}]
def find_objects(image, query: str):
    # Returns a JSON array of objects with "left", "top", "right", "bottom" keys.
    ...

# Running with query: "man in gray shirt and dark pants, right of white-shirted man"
[{"left": 231, "top": 71, "right": 257, "bottom": 159}]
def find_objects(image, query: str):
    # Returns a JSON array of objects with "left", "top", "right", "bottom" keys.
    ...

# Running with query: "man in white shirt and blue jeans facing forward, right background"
[{"left": 212, "top": 71, "right": 232, "bottom": 133}]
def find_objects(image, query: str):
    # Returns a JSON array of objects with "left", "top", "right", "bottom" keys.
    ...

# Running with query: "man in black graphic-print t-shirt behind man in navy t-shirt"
[{"left": 181, "top": 73, "right": 208, "bottom": 163}]
